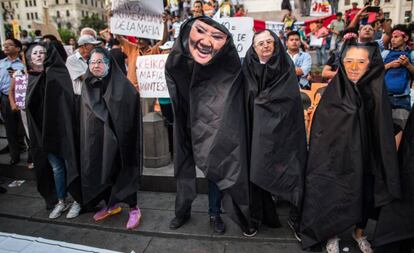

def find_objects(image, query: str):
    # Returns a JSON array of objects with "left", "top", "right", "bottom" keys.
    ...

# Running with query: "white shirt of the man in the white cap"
[{"left": 66, "top": 50, "right": 88, "bottom": 95}]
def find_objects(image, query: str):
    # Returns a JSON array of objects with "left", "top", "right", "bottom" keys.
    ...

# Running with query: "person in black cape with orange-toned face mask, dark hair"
[{"left": 301, "top": 40, "right": 401, "bottom": 252}]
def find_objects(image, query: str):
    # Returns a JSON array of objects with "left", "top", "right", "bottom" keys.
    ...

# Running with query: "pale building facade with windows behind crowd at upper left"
[{"left": 1, "top": 0, "right": 106, "bottom": 32}]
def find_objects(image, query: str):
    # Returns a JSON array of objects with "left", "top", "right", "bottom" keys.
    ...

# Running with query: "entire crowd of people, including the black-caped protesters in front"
[{"left": 0, "top": 1, "right": 414, "bottom": 253}]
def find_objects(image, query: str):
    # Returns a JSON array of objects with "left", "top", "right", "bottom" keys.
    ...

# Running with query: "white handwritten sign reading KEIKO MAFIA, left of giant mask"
[{"left": 136, "top": 54, "right": 170, "bottom": 98}]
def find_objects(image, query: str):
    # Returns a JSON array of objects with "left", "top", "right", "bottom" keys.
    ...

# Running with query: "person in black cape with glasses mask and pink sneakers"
[{"left": 81, "top": 48, "right": 142, "bottom": 229}]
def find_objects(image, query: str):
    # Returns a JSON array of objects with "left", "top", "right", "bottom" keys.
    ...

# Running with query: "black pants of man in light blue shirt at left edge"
[{"left": 1, "top": 94, "right": 24, "bottom": 160}]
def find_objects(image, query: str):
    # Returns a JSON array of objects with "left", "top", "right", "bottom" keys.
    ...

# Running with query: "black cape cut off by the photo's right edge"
[{"left": 373, "top": 105, "right": 414, "bottom": 247}]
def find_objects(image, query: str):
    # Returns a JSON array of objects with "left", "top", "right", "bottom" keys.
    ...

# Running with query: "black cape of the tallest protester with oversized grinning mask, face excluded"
[{"left": 166, "top": 17, "right": 249, "bottom": 231}]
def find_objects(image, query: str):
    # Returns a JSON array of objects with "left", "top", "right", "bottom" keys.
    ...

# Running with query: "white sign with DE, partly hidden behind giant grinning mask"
[{"left": 216, "top": 17, "right": 254, "bottom": 58}]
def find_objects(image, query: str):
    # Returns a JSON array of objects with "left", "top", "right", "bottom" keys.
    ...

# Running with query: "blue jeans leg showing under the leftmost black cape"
[{"left": 47, "top": 153, "right": 66, "bottom": 200}]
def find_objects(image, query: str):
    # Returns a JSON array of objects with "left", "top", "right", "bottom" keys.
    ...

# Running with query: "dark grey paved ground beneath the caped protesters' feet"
[{"left": 0, "top": 178, "right": 370, "bottom": 253}]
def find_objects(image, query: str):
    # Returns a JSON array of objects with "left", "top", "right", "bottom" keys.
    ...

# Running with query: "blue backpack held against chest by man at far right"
[{"left": 384, "top": 50, "right": 411, "bottom": 95}]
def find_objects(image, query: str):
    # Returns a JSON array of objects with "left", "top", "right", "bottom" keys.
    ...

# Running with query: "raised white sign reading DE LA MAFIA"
[{"left": 111, "top": 0, "right": 164, "bottom": 40}]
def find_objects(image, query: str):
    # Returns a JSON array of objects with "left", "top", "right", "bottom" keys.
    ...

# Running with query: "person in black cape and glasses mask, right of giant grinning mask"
[{"left": 243, "top": 30, "right": 307, "bottom": 235}]
